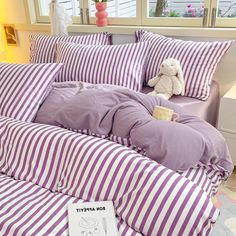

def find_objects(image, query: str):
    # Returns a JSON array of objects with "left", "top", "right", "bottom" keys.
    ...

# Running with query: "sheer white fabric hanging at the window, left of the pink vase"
[{"left": 49, "top": 0, "right": 71, "bottom": 36}]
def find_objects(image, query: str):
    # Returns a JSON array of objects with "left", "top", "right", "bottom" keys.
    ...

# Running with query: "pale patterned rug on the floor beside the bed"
[{"left": 211, "top": 174, "right": 236, "bottom": 236}]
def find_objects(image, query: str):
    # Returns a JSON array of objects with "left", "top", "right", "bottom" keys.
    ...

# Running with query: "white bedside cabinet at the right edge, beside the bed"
[{"left": 218, "top": 84, "right": 236, "bottom": 166}]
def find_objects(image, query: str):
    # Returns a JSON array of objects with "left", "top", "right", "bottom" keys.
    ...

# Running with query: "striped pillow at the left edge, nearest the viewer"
[{"left": 0, "top": 63, "right": 62, "bottom": 122}]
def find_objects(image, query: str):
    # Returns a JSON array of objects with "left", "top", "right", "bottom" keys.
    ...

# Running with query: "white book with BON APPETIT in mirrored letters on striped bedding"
[{"left": 68, "top": 201, "right": 119, "bottom": 236}]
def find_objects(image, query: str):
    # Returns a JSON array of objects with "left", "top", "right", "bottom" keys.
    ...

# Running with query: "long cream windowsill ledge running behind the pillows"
[{"left": 16, "top": 24, "right": 236, "bottom": 39}]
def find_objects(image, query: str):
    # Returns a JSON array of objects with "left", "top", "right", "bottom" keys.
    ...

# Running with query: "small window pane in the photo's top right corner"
[{"left": 218, "top": 0, "right": 236, "bottom": 18}]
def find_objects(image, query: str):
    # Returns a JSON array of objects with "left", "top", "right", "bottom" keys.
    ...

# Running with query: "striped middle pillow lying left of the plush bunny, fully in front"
[{"left": 56, "top": 42, "right": 149, "bottom": 91}]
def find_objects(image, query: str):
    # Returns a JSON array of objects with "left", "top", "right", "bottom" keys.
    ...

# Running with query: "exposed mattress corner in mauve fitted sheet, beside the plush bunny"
[{"left": 142, "top": 81, "right": 220, "bottom": 127}]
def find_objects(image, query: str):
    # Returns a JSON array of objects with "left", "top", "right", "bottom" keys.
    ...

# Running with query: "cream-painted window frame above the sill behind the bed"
[{"left": 32, "top": 0, "right": 236, "bottom": 28}]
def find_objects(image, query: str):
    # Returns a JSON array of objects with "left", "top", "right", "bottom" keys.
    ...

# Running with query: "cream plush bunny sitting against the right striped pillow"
[{"left": 148, "top": 58, "right": 185, "bottom": 99}]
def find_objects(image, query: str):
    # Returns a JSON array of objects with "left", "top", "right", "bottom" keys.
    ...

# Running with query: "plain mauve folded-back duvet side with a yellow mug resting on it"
[{"left": 35, "top": 82, "right": 233, "bottom": 173}]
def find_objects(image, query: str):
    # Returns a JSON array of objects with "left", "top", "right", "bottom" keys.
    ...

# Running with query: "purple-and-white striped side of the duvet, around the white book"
[{"left": 0, "top": 117, "right": 222, "bottom": 236}]
